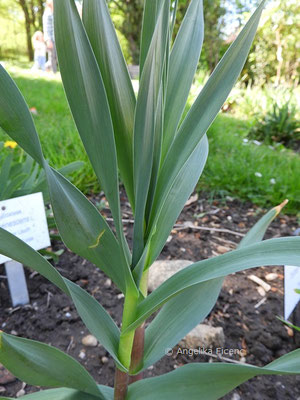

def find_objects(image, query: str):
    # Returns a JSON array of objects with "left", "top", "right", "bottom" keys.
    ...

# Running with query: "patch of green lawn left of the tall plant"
[{"left": 0, "top": 62, "right": 99, "bottom": 193}]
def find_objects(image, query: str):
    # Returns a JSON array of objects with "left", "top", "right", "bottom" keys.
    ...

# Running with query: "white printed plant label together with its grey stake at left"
[{"left": 0, "top": 193, "right": 50, "bottom": 307}]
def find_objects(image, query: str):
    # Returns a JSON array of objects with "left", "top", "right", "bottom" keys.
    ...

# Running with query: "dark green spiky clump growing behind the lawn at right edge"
[{"left": 248, "top": 101, "right": 300, "bottom": 149}]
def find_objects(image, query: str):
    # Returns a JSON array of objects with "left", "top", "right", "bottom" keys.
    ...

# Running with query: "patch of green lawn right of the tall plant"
[{"left": 198, "top": 114, "right": 300, "bottom": 213}]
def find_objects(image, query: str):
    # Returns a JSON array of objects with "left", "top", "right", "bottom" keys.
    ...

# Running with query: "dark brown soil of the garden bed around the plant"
[{"left": 0, "top": 193, "right": 300, "bottom": 400}]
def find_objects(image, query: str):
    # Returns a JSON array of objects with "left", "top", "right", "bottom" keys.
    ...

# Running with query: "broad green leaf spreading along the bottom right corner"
[{"left": 126, "top": 349, "right": 300, "bottom": 400}]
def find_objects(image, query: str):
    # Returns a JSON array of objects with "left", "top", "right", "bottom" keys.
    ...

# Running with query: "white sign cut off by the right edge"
[{"left": 284, "top": 265, "right": 300, "bottom": 319}]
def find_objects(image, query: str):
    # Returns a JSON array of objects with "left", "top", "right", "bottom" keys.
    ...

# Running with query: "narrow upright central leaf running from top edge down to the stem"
[{"left": 133, "top": 0, "right": 170, "bottom": 265}]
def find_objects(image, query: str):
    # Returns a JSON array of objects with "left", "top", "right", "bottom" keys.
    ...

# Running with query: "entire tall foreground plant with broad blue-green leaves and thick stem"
[{"left": 0, "top": 0, "right": 300, "bottom": 400}]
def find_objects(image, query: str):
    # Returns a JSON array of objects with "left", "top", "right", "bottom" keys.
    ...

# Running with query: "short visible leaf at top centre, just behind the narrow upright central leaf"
[{"left": 140, "top": 0, "right": 165, "bottom": 77}]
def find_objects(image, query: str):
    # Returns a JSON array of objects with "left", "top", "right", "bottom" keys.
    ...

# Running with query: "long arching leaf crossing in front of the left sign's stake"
[{"left": 0, "top": 228, "right": 124, "bottom": 369}]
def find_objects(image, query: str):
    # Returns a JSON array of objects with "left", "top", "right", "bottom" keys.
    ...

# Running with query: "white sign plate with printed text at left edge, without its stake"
[{"left": 0, "top": 193, "right": 50, "bottom": 264}]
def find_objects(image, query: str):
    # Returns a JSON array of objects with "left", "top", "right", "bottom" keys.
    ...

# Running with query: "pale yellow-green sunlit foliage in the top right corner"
[{"left": 244, "top": 0, "right": 300, "bottom": 86}]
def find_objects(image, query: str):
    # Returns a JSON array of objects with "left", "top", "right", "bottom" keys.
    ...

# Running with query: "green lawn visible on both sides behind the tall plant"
[{"left": 0, "top": 65, "right": 300, "bottom": 213}]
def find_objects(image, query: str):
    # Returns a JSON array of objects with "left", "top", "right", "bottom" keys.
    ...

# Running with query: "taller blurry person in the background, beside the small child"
[{"left": 43, "top": 0, "right": 57, "bottom": 74}]
